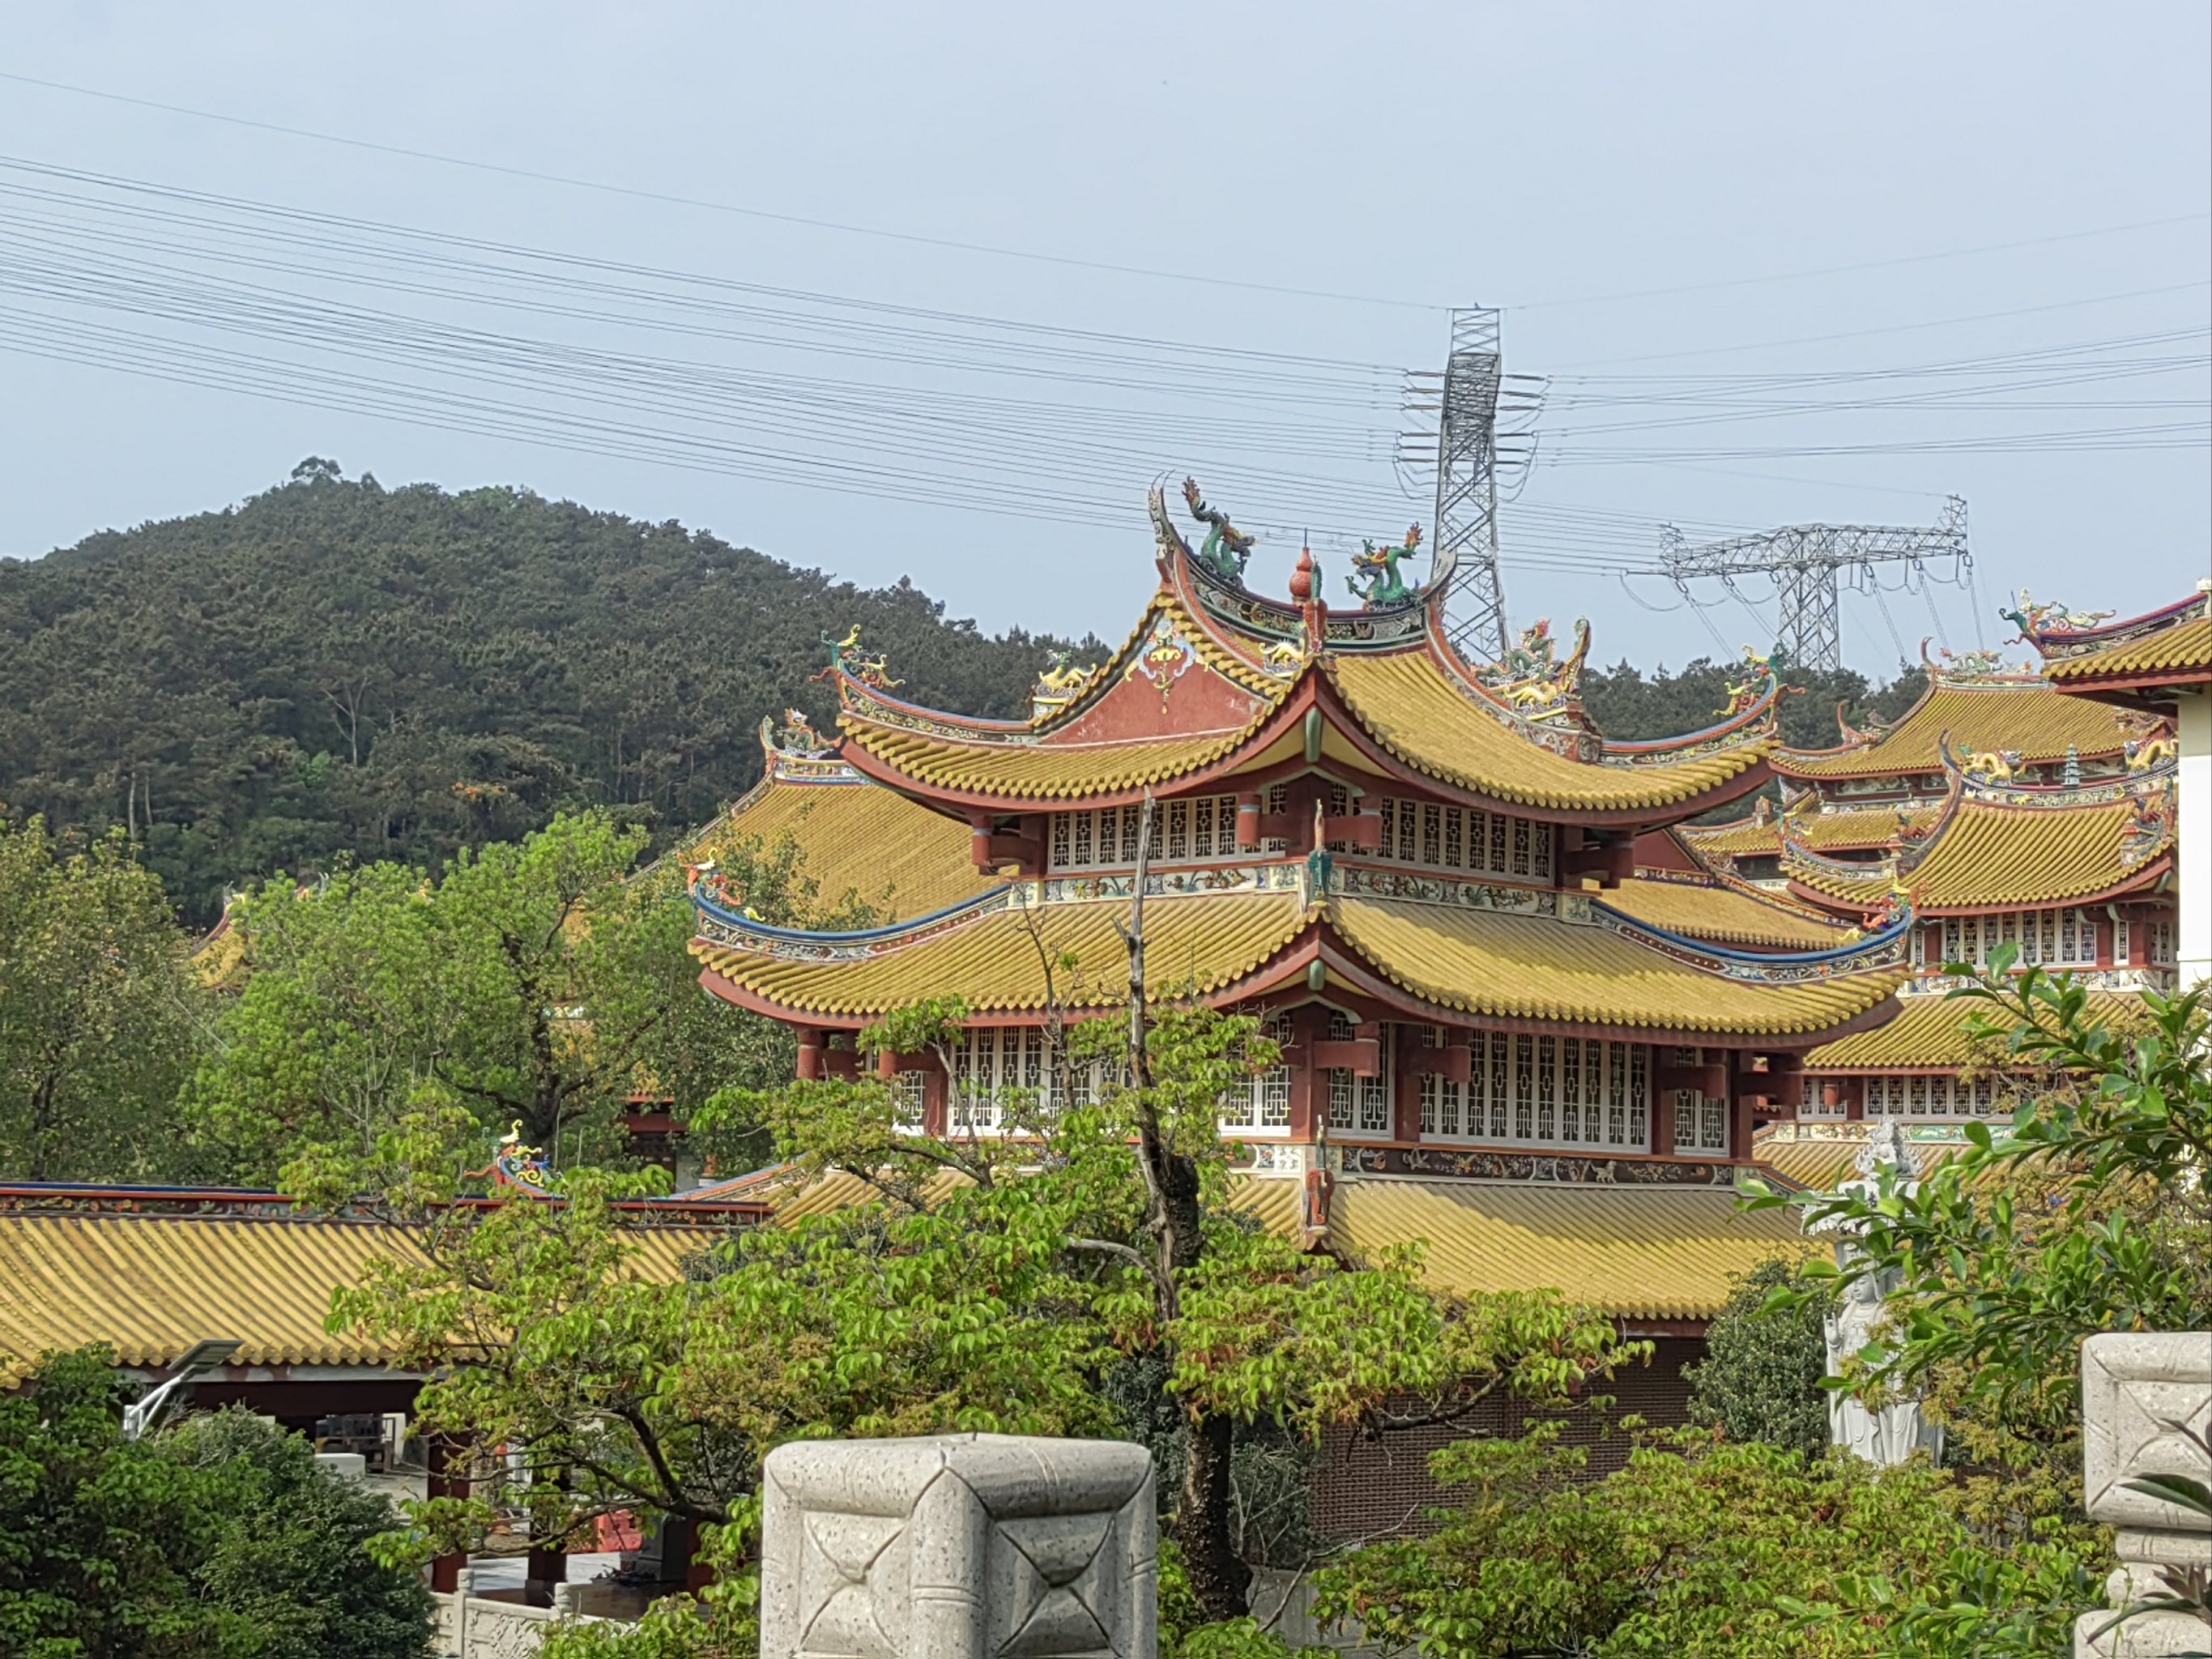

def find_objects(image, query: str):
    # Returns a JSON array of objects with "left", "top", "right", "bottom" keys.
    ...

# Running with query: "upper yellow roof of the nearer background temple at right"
[{"left": 1783, "top": 801, "right": 2148, "bottom": 909}]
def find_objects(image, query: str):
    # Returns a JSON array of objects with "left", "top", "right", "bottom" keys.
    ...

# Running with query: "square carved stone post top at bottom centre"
[{"left": 761, "top": 1433, "right": 1159, "bottom": 1659}]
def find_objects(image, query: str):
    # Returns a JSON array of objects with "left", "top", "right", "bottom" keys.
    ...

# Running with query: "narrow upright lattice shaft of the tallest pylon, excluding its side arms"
[{"left": 1435, "top": 308, "right": 1507, "bottom": 661}]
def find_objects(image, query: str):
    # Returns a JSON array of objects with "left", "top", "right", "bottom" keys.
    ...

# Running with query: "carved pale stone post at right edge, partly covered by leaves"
[{"left": 2075, "top": 1332, "right": 2212, "bottom": 1659}]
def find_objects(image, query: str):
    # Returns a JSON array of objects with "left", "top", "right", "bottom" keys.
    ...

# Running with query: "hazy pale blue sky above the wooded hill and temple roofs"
[{"left": 0, "top": 0, "right": 2212, "bottom": 668}]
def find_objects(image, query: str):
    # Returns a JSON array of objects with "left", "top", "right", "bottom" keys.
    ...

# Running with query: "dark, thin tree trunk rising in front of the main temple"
[{"left": 1123, "top": 796, "right": 1252, "bottom": 1619}]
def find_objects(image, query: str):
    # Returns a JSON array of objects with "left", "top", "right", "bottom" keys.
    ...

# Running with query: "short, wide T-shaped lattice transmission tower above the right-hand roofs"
[{"left": 1659, "top": 496, "right": 1973, "bottom": 668}]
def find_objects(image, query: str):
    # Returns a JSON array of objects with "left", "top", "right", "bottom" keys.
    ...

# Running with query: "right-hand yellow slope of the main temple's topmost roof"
[{"left": 1328, "top": 650, "right": 1770, "bottom": 812}]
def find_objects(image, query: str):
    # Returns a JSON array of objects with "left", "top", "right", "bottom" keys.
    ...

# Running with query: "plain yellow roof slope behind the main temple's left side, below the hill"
[{"left": 684, "top": 774, "right": 998, "bottom": 923}]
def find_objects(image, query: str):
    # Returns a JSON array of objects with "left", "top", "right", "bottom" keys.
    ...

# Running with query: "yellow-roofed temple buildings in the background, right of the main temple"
[{"left": 1677, "top": 653, "right": 2179, "bottom": 1124}]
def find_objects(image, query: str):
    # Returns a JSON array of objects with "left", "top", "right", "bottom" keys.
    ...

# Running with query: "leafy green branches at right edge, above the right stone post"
[{"left": 1758, "top": 960, "right": 2212, "bottom": 1460}]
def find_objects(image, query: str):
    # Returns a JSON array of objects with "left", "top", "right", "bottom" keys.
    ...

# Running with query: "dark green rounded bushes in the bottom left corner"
[{"left": 0, "top": 1347, "right": 432, "bottom": 1659}]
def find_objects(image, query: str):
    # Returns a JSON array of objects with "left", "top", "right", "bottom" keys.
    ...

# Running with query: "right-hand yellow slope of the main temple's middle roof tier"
[{"left": 1329, "top": 898, "right": 1903, "bottom": 1038}]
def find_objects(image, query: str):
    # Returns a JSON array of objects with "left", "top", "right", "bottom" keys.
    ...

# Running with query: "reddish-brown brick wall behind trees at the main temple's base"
[{"left": 1314, "top": 1336, "right": 1706, "bottom": 1540}]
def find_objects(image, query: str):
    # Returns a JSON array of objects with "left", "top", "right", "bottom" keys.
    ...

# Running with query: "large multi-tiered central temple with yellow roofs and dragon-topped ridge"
[{"left": 693, "top": 488, "right": 1913, "bottom": 1360}]
